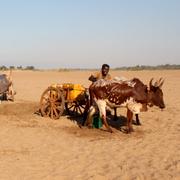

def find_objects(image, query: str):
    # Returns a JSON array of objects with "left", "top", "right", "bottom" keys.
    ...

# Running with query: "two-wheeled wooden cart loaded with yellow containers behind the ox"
[{"left": 40, "top": 83, "right": 88, "bottom": 119}]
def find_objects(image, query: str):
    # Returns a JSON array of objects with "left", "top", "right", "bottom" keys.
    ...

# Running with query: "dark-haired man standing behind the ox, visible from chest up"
[{"left": 89, "top": 64, "right": 111, "bottom": 82}]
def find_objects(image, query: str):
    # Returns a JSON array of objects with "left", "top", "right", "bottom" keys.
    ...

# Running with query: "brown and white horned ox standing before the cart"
[{"left": 85, "top": 78, "right": 165, "bottom": 133}]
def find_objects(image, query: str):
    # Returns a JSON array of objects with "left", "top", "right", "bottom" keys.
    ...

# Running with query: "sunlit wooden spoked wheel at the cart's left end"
[{"left": 40, "top": 87, "right": 65, "bottom": 119}]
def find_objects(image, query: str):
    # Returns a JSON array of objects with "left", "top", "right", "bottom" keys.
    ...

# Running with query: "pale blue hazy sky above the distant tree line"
[{"left": 0, "top": 0, "right": 180, "bottom": 68}]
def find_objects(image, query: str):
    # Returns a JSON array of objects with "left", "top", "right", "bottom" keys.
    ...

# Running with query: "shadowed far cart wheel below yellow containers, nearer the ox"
[{"left": 65, "top": 98, "right": 86, "bottom": 116}]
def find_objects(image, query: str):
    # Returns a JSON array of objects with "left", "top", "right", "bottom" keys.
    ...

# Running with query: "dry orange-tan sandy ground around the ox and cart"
[{"left": 0, "top": 70, "right": 180, "bottom": 180}]
